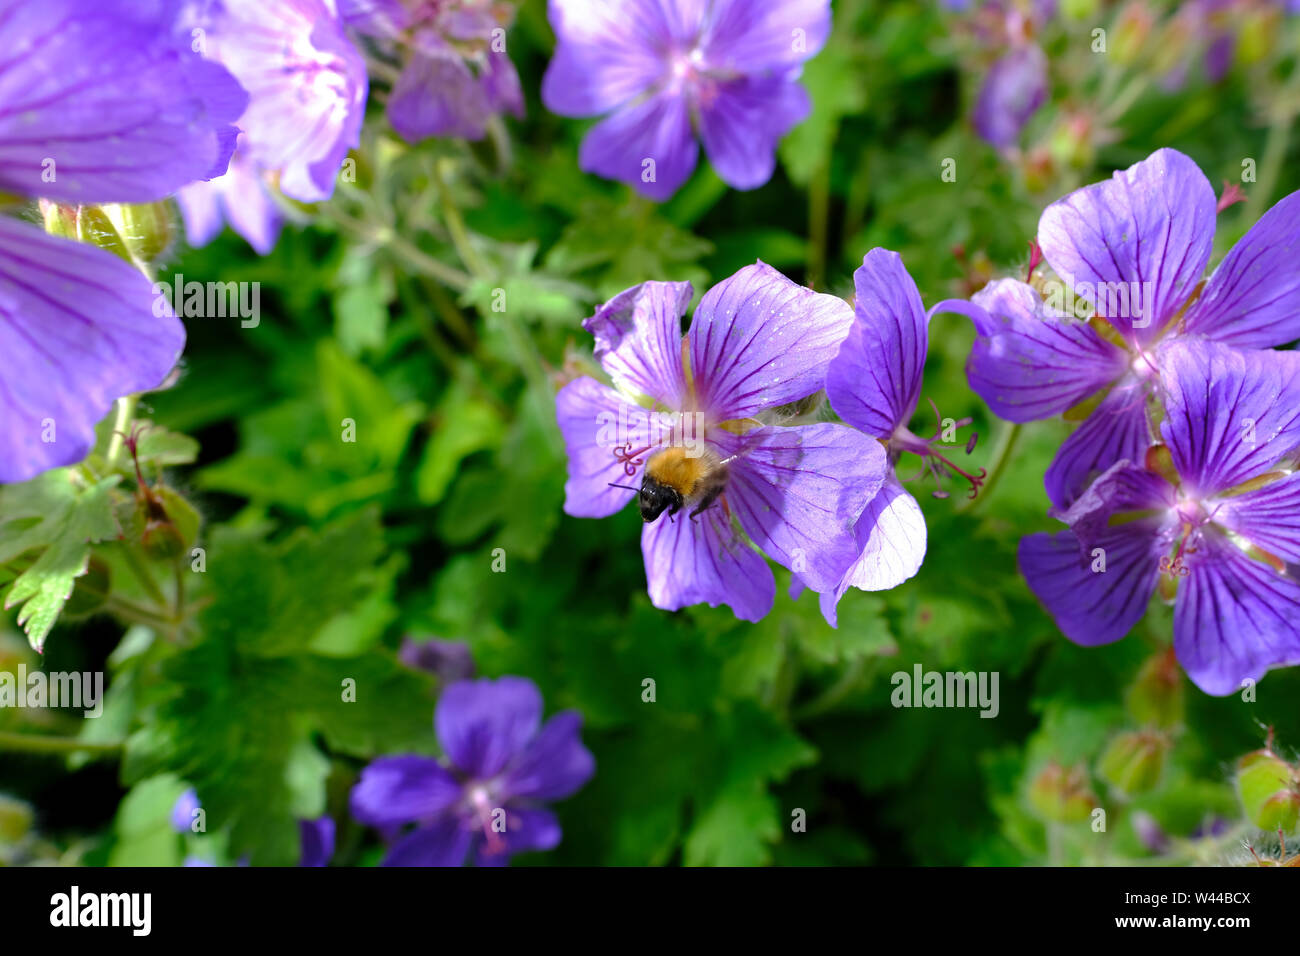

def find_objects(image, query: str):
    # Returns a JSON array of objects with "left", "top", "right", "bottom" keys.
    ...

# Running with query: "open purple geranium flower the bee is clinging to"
[{"left": 555, "top": 263, "right": 887, "bottom": 620}]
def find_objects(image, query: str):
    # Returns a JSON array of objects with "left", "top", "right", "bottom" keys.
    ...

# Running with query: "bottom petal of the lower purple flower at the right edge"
[{"left": 1174, "top": 532, "right": 1300, "bottom": 696}]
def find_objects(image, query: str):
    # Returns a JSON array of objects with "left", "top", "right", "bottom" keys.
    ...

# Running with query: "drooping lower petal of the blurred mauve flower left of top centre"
[{"left": 389, "top": 48, "right": 491, "bottom": 143}]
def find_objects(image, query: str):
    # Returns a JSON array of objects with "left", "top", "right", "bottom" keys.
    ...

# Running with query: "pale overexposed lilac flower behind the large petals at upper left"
[{"left": 179, "top": 0, "right": 368, "bottom": 254}]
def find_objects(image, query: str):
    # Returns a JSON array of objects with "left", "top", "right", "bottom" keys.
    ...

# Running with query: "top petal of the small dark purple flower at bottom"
[{"left": 433, "top": 678, "right": 542, "bottom": 780}]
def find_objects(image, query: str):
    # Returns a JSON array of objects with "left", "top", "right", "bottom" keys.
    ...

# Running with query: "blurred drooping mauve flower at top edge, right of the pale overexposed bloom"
[{"left": 339, "top": 0, "right": 524, "bottom": 143}]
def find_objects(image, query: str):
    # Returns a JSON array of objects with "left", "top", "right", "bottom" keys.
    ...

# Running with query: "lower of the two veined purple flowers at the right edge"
[{"left": 1019, "top": 338, "right": 1300, "bottom": 695}]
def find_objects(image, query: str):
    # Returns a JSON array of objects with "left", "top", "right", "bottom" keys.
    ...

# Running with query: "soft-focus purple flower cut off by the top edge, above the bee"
[{"left": 542, "top": 0, "right": 831, "bottom": 200}]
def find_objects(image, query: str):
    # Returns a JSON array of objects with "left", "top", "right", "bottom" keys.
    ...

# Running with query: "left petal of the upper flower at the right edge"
[{"left": 966, "top": 278, "right": 1127, "bottom": 421}]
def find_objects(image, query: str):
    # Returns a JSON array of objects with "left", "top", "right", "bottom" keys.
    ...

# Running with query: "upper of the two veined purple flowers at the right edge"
[{"left": 966, "top": 150, "right": 1300, "bottom": 507}]
